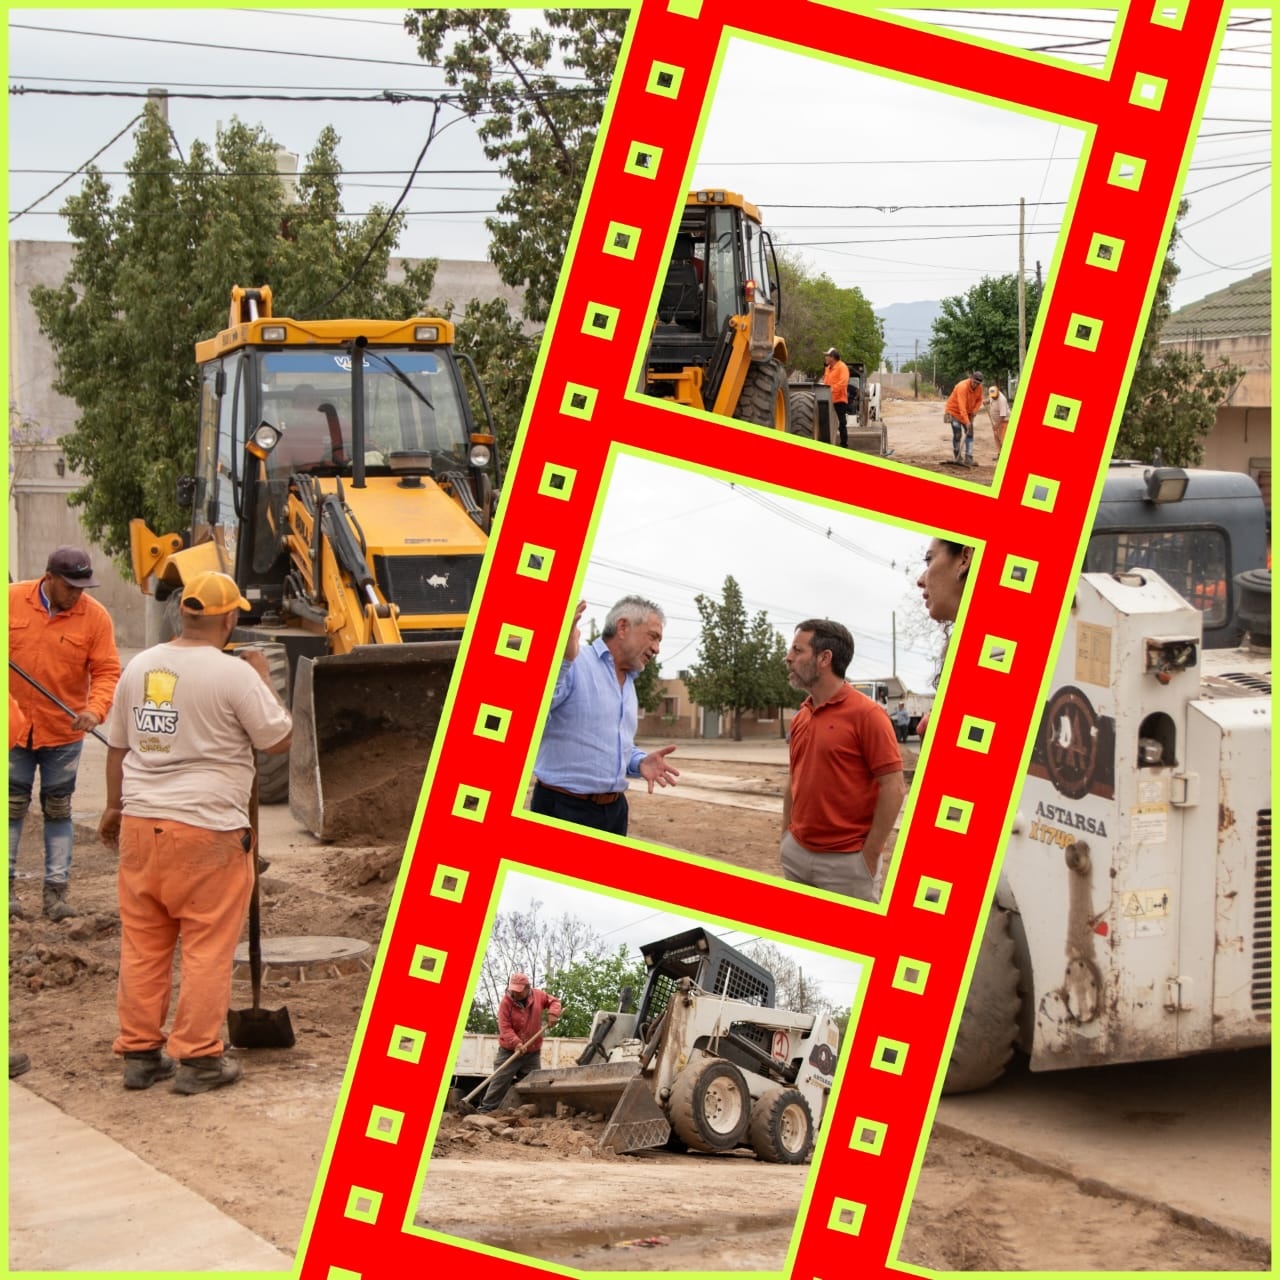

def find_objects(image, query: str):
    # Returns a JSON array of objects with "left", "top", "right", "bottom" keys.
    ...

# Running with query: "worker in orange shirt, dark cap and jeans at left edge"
[{"left": 9, "top": 547, "right": 120, "bottom": 920}]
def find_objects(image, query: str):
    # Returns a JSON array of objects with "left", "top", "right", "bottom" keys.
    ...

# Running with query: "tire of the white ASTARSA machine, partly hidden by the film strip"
[{"left": 942, "top": 905, "right": 1021, "bottom": 1093}]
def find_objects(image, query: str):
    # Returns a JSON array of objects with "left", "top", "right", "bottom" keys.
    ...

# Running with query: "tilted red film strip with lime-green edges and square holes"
[{"left": 301, "top": 0, "right": 1222, "bottom": 1280}]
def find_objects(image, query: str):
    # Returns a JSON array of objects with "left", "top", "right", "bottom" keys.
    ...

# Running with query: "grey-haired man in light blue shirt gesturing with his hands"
[{"left": 530, "top": 595, "right": 680, "bottom": 836}]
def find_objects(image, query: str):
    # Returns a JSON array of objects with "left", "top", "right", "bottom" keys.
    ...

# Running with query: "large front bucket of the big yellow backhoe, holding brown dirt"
[{"left": 289, "top": 640, "right": 458, "bottom": 845}]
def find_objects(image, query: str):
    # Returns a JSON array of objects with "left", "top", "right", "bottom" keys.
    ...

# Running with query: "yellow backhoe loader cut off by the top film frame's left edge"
[{"left": 644, "top": 189, "right": 790, "bottom": 430}]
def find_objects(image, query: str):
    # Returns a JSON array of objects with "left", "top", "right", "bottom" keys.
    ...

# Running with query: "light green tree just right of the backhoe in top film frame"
[{"left": 778, "top": 251, "right": 884, "bottom": 378}]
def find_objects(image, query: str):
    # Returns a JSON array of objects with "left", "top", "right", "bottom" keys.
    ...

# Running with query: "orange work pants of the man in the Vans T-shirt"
[{"left": 111, "top": 817, "right": 256, "bottom": 1060}]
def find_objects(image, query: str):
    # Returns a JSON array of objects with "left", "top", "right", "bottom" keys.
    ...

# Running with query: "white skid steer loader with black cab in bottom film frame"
[{"left": 513, "top": 929, "right": 840, "bottom": 1165}]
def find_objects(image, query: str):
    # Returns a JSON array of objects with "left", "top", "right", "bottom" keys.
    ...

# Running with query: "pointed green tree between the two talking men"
[{"left": 685, "top": 575, "right": 786, "bottom": 742}]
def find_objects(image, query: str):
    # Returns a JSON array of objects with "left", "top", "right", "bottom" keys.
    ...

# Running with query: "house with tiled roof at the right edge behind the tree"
[{"left": 1160, "top": 266, "right": 1271, "bottom": 508}]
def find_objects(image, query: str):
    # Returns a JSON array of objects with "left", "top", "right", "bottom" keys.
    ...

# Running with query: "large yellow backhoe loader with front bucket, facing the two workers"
[{"left": 131, "top": 287, "right": 500, "bottom": 842}]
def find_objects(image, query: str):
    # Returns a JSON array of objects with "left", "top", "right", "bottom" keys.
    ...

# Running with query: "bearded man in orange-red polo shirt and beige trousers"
[{"left": 781, "top": 618, "right": 906, "bottom": 902}]
